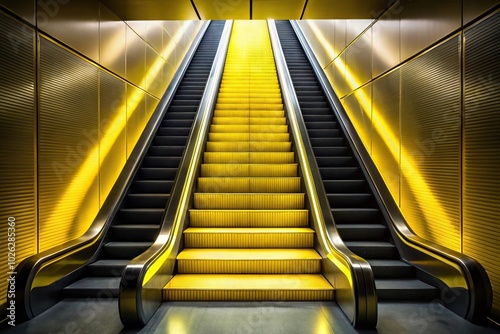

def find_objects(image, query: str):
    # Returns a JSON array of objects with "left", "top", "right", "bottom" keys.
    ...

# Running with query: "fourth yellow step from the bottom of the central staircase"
[{"left": 189, "top": 209, "right": 309, "bottom": 227}]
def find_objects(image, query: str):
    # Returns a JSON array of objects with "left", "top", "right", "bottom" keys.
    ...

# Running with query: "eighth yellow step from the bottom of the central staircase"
[{"left": 203, "top": 152, "right": 295, "bottom": 164}]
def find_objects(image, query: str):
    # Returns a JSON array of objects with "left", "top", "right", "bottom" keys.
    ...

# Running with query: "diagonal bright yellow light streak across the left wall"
[{"left": 47, "top": 21, "right": 195, "bottom": 243}]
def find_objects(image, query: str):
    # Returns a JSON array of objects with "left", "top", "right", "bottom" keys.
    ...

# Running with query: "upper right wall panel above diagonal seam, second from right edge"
[{"left": 400, "top": 0, "right": 462, "bottom": 61}]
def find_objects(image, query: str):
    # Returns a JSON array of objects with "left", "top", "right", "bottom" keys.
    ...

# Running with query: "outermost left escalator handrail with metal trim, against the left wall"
[{"left": 16, "top": 22, "right": 213, "bottom": 321}]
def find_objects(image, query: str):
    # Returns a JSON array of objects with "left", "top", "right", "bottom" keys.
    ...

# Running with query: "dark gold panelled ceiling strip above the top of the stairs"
[{"left": 101, "top": 0, "right": 396, "bottom": 20}]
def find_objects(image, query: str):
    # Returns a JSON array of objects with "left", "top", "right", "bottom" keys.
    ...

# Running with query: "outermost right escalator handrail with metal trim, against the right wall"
[{"left": 291, "top": 22, "right": 493, "bottom": 322}]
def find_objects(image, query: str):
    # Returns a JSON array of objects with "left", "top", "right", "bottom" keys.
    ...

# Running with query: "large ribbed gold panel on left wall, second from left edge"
[{"left": 38, "top": 38, "right": 99, "bottom": 251}]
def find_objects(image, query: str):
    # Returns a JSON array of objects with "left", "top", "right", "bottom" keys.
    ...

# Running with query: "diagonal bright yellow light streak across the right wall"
[{"left": 311, "top": 25, "right": 453, "bottom": 243}]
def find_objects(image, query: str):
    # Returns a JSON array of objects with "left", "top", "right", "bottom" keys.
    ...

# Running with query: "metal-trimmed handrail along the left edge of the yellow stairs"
[{"left": 119, "top": 21, "right": 232, "bottom": 326}]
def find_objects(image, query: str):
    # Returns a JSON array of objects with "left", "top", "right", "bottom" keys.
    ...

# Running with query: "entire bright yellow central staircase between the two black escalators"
[{"left": 164, "top": 21, "right": 333, "bottom": 300}]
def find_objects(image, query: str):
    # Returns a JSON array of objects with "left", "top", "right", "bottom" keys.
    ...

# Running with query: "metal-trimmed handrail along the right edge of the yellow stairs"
[{"left": 268, "top": 20, "right": 377, "bottom": 328}]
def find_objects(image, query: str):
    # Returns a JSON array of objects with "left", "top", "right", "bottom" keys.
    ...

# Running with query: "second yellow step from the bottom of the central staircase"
[{"left": 177, "top": 248, "right": 321, "bottom": 274}]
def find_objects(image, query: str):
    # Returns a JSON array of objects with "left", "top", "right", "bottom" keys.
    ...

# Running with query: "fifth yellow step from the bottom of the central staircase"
[{"left": 194, "top": 193, "right": 304, "bottom": 210}]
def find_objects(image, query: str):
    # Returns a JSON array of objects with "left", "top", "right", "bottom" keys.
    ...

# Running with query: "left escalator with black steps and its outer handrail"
[{"left": 15, "top": 21, "right": 225, "bottom": 319}]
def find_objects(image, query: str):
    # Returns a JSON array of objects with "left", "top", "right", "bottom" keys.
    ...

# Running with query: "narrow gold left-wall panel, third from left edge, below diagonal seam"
[{"left": 99, "top": 71, "right": 127, "bottom": 206}]
